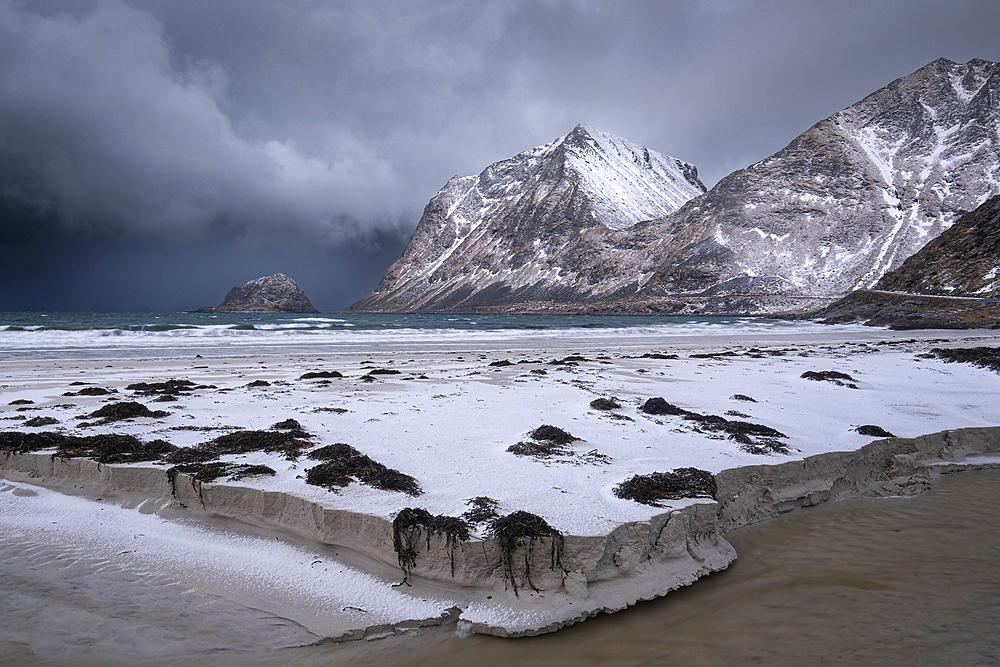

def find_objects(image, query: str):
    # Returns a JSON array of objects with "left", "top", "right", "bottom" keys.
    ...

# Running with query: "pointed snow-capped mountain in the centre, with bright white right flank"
[{"left": 351, "top": 125, "right": 705, "bottom": 311}]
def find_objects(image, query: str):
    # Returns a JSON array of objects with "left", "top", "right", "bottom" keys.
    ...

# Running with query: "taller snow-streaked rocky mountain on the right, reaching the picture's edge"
[{"left": 643, "top": 59, "right": 1000, "bottom": 306}]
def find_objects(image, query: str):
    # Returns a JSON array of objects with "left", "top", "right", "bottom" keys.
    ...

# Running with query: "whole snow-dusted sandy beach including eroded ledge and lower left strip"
[{"left": 0, "top": 326, "right": 1000, "bottom": 657}]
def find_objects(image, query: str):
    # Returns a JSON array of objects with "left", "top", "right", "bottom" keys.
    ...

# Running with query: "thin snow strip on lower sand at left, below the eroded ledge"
[{"left": 0, "top": 474, "right": 452, "bottom": 637}]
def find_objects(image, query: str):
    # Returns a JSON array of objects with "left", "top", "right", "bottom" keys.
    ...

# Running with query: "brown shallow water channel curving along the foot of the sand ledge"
[{"left": 0, "top": 470, "right": 1000, "bottom": 667}]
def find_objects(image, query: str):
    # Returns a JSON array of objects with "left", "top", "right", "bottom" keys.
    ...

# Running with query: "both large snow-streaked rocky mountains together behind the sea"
[{"left": 352, "top": 59, "right": 1000, "bottom": 314}]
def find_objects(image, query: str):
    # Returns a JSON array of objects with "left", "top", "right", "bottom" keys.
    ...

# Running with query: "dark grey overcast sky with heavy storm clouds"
[{"left": 0, "top": 0, "right": 1000, "bottom": 311}]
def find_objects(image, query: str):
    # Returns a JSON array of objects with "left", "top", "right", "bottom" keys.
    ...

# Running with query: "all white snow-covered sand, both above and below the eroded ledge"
[{"left": 0, "top": 327, "right": 1000, "bottom": 652}]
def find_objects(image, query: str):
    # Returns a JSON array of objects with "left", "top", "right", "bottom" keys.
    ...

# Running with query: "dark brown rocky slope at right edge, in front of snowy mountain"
[{"left": 816, "top": 196, "right": 1000, "bottom": 329}]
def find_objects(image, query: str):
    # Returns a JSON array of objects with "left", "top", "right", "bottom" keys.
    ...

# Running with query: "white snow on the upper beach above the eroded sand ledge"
[{"left": 0, "top": 326, "right": 1000, "bottom": 535}]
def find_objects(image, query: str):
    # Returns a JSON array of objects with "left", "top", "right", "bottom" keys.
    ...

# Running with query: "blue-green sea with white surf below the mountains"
[{"left": 0, "top": 313, "right": 936, "bottom": 361}]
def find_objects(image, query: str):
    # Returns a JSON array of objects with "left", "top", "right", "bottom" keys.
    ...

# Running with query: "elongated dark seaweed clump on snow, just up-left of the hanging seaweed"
[{"left": 306, "top": 442, "right": 423, "bottom": 497}]
